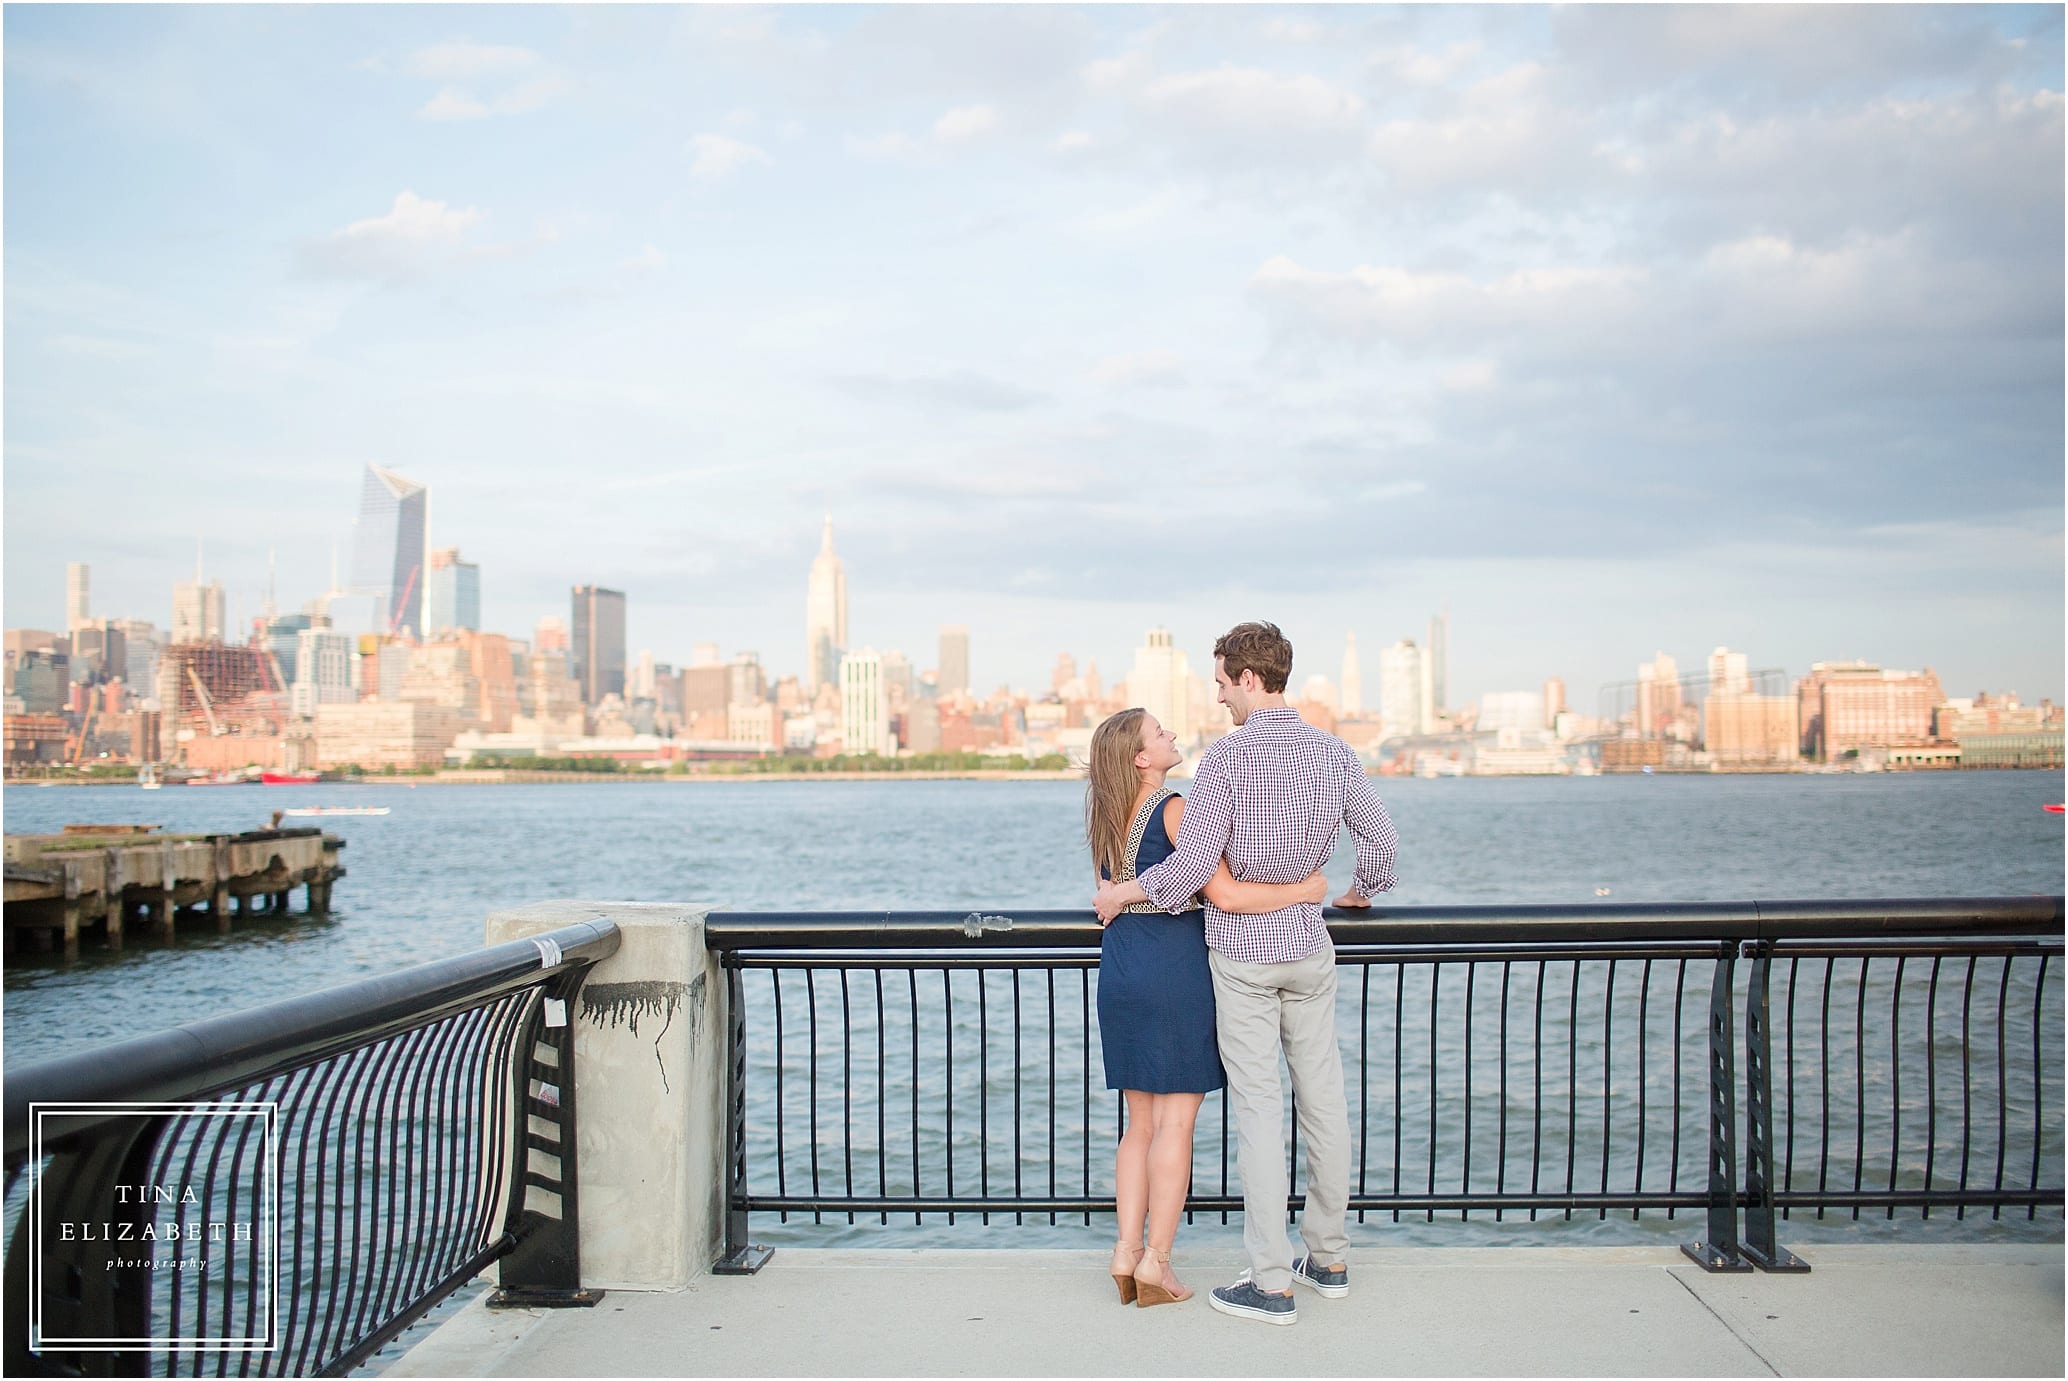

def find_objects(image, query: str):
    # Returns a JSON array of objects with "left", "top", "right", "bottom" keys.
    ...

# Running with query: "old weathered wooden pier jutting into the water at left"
[{"left": 4, "top": 825, "right": 345, "bottom": 959}]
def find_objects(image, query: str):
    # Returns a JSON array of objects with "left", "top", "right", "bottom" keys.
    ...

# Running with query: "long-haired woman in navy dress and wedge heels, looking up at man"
[{"left": 1084, "top": 709, "right": 1328, "bottom": 1307}]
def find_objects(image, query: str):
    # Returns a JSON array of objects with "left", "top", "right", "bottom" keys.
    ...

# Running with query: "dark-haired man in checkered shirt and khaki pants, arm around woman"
[{"left": 1094, "top": 622, "right": 1398, "bottom": 1323}]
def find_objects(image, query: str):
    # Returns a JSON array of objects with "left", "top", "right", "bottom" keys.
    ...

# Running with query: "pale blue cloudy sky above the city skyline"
[{"left": 4, "top": 6, "right": 2064, "bottom": 709}]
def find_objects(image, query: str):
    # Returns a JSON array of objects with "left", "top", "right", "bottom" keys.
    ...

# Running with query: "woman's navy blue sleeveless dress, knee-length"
[{"left": 1098, "top": 792, "right": 1226, "bottom": 1094}]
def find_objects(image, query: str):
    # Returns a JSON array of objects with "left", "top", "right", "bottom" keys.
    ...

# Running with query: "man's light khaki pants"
[{"left": 1208, "top": 945, "right": 1350, "bottom": 1290}]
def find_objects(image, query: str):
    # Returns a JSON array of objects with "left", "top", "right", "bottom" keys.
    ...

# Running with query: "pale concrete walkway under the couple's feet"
[{"left": 387, "top": 1245, "right": 2064, "bottom": 1377}]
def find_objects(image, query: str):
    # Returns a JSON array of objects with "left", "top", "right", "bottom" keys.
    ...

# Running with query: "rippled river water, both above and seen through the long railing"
[{"left": 4, "top": 773, "right": 2062, "bottom": 1247}]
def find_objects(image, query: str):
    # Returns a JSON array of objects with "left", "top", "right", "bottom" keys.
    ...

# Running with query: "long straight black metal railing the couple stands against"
[{"left": 705, "top": 897, "right": 2062, "bottom": 1269}]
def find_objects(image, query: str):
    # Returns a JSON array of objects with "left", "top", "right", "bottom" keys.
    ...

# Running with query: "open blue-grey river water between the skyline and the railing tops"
[{"left": 4, "top": 773, "right": 2064, "bottom": 1245}]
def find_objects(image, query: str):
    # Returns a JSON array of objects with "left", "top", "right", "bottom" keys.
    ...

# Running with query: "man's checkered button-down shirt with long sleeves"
[{"left": 1137, "top": 709, "right": 1400, "bottom": 963}]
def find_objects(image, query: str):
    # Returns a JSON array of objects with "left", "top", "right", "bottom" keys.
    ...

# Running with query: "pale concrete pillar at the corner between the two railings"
[{"left": 488, "top": 901, "right": 726, "bottom": 1290}]
